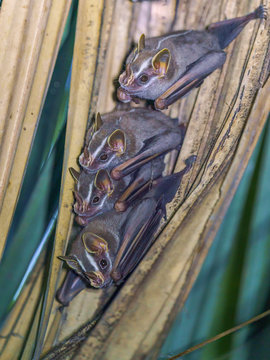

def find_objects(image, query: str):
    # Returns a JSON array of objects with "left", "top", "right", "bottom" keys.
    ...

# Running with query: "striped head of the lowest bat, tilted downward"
[{"left": 59, "top": 231, "right": 112, "bottom": 288}]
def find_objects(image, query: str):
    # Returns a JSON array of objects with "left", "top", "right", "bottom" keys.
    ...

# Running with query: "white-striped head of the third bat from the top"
[{"left": 73, "top": 169, "right": 114, "bottom": 226}]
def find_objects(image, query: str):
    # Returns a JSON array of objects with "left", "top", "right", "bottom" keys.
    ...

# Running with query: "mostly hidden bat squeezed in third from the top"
[{"left": 70, "top": 156, "right": 165, "bottom": 226}]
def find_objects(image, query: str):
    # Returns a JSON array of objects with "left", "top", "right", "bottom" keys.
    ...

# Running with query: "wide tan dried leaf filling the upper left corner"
[{"left": 0, "top": 0, "right": 71, "bottom": 257}]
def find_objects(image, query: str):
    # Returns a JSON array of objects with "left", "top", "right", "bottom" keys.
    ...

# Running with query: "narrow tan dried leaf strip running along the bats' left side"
[{"left": 28, "top": 0, "right": 109, "bottom": 357}]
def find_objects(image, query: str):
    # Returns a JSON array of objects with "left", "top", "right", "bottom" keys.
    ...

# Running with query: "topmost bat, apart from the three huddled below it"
[{"left": 117, "top": 5, "right": 267, "bottom": 110}]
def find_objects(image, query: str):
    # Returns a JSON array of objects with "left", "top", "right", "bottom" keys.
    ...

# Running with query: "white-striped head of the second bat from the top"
[{"left": 79, "top": 115, "right": 126, "bottom": 172}]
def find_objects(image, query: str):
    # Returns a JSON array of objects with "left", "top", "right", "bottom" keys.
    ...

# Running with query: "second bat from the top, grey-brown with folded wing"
[{"left": 79, "top": 108, "right": 184, "bottom": 180}]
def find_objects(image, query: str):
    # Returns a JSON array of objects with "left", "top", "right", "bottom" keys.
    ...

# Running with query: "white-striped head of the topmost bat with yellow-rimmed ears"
[{"left": 117, "top": 34, "right": 171, "bottom": 102}]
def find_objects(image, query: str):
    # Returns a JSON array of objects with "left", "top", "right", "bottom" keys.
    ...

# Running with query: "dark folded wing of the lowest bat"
[{"left": 111, "top": 172, "right": 186, "bottom": 283}]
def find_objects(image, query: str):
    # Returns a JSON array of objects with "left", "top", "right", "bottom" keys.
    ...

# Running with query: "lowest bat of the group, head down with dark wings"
[{"left": 56, "top": 156, "right": 196, "bottom": 305}]
